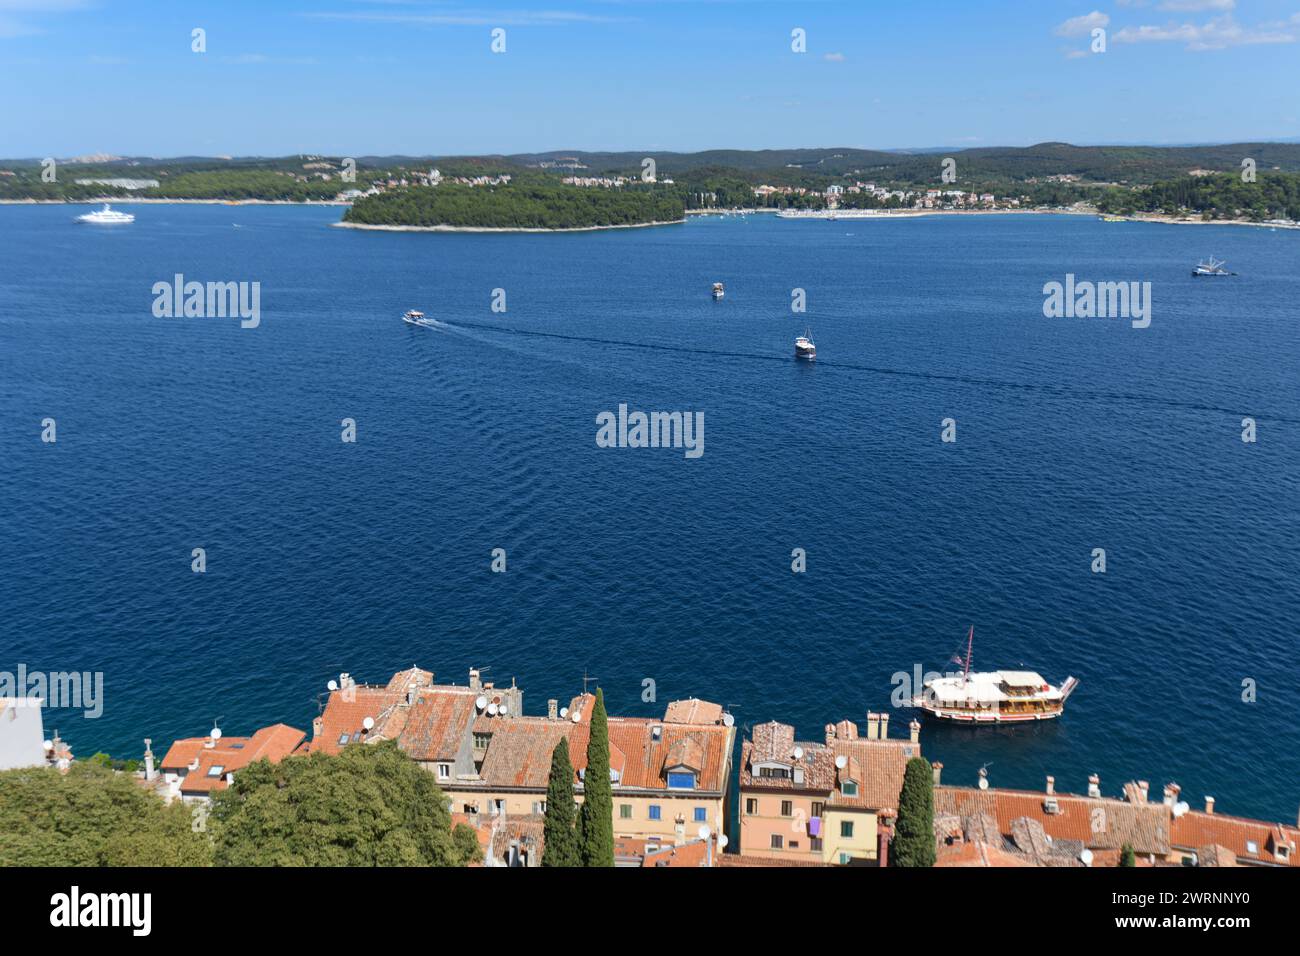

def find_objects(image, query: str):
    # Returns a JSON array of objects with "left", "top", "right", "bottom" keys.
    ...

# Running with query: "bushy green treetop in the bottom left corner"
[{"left": 0, "top": 761, "right": 212, "bottom": 866}]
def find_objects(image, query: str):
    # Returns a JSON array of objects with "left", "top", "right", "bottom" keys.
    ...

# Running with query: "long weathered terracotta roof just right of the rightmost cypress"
[{"left": 935, "top": 786, "right": 1171, "bottom": 856}]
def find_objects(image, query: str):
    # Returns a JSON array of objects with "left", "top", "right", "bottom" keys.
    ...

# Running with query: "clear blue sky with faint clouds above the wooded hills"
[{"left": 0, "top": 0, "right": 1300, "bottom": 157}]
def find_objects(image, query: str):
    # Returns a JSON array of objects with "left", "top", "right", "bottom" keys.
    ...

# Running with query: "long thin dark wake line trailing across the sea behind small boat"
[{"left": 445, "top": 321, "right": 1300, "bottom": 425}]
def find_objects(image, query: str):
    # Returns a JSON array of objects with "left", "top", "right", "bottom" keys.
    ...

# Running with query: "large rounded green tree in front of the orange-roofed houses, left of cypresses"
[{"left": 212, "top": 741, "right": 480, "bottom": 866}]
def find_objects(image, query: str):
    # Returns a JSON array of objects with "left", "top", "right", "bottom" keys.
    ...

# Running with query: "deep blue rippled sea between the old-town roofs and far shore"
[{"left": 0, "top": 206, "right": 1300, "bottom": 819}]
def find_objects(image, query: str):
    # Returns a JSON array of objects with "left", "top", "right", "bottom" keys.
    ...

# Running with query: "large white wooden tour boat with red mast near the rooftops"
[{"left": 911, "top": 627, "right": 1079, "bottom": 723}]
